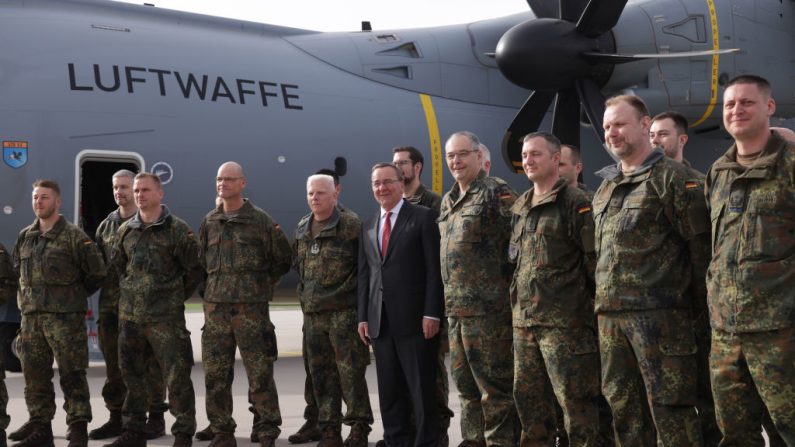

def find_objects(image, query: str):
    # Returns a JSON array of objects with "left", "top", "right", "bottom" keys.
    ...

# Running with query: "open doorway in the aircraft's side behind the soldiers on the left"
[{"left": 75, "top": 150, "right": 145, "bottom": 360}]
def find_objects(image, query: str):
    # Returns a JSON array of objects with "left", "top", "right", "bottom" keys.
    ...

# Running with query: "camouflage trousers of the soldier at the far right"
[{"left": 709, "top": 327, "right": 795, "bottom": 447}]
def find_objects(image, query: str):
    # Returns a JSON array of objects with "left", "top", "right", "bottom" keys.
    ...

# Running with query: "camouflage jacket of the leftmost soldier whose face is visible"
[{"left": 14, "top": 216, "right": 106, "bottom": 314}]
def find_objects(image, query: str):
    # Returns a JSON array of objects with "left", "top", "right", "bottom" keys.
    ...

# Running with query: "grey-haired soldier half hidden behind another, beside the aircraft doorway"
[{"left": 88, "top": 169, "right": 168, "bottom": 439}]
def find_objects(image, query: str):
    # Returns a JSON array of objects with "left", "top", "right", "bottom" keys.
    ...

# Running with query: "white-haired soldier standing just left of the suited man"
[{"left": 293, "top": 175, "right": 373, "bottom": 447}]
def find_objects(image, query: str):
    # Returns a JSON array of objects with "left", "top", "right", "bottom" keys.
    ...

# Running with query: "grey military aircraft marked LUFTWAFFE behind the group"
[{"left": 0, "top": 0, "right": 795, "bottom": 360}]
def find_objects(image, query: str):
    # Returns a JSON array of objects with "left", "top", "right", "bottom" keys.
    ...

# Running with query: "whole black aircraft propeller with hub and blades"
[{"left": 495, "top": 0, "right": 738, "bottom": 172}]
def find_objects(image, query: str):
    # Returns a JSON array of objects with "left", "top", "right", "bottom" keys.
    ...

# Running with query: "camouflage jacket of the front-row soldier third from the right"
[{"left": 508, "top": 179, "right": 596, "bottom": 327}]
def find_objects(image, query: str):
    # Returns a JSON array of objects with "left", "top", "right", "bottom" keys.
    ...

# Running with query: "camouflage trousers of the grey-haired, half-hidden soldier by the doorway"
[{"left": 97, "top": 313, "right": 168, "bottom": 413}]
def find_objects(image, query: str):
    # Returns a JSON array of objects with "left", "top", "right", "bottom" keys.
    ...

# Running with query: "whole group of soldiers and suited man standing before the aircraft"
[{"left": 0, "top": 71, "right": 795, "bottom": 447}]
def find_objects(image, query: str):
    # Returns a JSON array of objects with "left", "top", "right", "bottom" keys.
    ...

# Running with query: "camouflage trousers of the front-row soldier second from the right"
[{"left": 598, "top": 309, "right": 702, "bottom": 447}]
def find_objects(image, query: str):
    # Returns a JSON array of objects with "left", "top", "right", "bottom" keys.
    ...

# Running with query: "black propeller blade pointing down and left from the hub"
[{"left": 502, "top": 90, "right": 555, "bottom": 172}]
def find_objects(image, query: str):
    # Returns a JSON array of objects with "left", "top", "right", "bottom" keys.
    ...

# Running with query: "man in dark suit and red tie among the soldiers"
[{"left": 359, "top": 163, "right": 444, "bottom": 447}]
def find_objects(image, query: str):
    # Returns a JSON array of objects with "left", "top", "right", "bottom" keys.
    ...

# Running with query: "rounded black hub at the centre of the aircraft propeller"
[{"left": 496, "top": 18, "right": 615, "bottom": 90}]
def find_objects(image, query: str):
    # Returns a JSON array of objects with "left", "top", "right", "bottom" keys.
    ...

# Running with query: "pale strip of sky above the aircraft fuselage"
[{"left": 110, "top": 0, "right": 529, "bottom": 31}]
